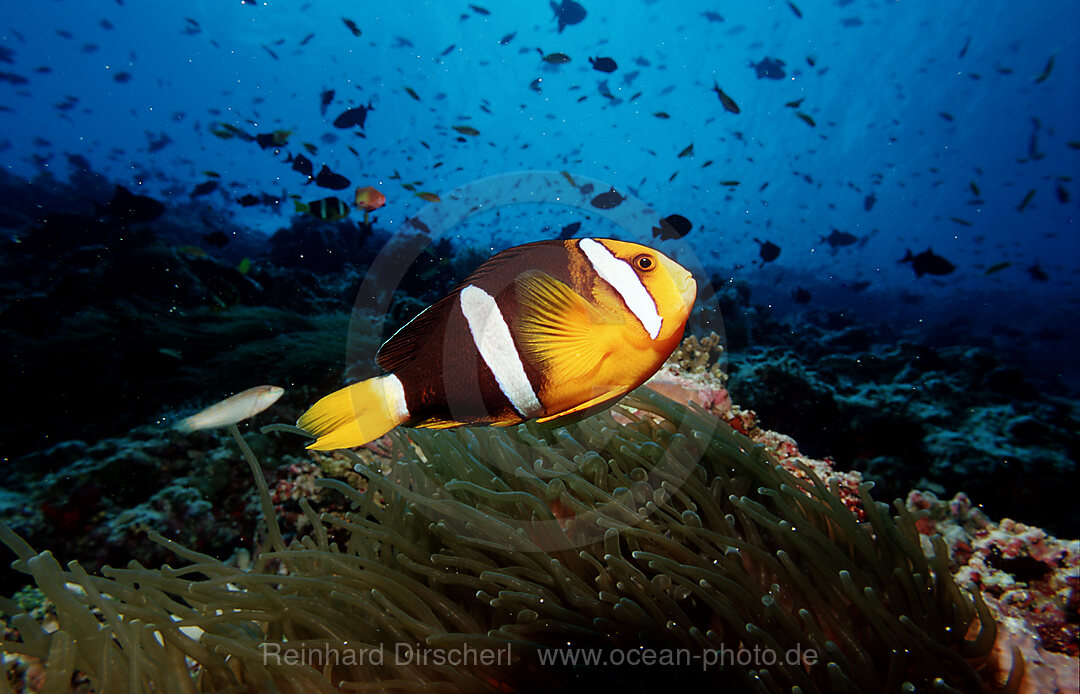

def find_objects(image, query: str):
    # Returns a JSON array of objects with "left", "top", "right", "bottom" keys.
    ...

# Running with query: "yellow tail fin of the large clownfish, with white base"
[{"left": 296, "top": 376, "right": 407, "bottom": 450}]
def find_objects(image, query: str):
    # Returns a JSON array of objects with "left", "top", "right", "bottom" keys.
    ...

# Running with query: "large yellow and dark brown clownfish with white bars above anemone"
[{"left": 297, "top": 239, "right": 698, "bottom": 450}]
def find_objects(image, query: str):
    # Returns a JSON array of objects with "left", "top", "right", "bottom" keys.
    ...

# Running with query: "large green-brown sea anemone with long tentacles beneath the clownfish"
[{"left": 0, "top": 390, "right": 1023, "bottom": 694}]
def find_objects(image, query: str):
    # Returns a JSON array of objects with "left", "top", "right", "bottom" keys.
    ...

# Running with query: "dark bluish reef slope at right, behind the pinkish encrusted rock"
[{"left": 729, "top": 336, "right": 1080, "bottom": 535}]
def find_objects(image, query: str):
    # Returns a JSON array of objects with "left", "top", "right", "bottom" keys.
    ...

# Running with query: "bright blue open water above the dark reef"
[{"left": 0, "top": 0, "right": 1080, "bottom": 387}]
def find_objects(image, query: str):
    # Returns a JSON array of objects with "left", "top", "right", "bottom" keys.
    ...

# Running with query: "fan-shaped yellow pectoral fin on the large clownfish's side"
[{"left": 514, "top": 272, "right": 622, "bottom": 383}]
